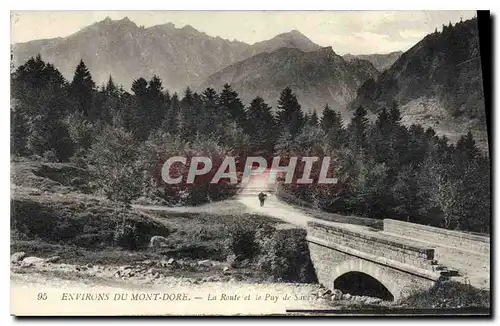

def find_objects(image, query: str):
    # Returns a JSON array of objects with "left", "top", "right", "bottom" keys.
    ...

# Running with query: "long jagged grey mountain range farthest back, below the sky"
[{"left": 12, "top": 17, "right": 319, "bottom": 91}]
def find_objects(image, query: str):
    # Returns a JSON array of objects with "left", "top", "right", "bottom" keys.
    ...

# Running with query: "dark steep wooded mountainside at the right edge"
[{"left": 350, "top": 18, "right": 487, "bottom": 146}]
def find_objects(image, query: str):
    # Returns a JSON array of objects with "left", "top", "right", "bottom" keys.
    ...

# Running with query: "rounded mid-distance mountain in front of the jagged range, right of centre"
[{"left": 200, "top": 47, "right": 378, "bottom": 116}]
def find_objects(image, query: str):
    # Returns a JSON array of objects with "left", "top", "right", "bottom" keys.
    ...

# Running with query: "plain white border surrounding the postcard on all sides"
[{"left": 0, "top": 0, "right": 500, "bottom": 325}]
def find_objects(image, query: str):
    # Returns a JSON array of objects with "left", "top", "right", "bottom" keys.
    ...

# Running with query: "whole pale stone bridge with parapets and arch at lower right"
[{"left": 307, "top": 219, "right": 490, "bottom": 301}]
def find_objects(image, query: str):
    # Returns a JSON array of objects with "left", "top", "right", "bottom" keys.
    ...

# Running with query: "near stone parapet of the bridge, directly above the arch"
[{"left": 307, "top": 222, "right": 435, "bottom": 271}]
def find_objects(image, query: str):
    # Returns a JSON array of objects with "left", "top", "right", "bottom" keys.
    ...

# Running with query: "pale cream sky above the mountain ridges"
[{"left": 11, "top": 10, "right": 476, "bottom": 55}]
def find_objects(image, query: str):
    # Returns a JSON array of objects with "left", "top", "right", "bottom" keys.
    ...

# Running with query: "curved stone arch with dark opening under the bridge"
[{"left": 331, "top": 258, "right": 401, "bottom": 301}]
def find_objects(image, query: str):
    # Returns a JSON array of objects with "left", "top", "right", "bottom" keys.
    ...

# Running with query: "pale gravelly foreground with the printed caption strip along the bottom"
[{"left": 11, "top": 255, "right": 391, "bottom": 315}]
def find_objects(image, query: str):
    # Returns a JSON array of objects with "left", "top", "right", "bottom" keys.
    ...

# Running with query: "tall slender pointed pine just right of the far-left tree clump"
[{"left": 71, "top": 60, "right": 96, "bottom": 119}]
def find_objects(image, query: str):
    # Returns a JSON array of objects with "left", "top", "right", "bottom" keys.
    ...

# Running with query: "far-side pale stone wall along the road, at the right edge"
[{"left": 384, "top": 219, "right": 490, "bottom": 255}]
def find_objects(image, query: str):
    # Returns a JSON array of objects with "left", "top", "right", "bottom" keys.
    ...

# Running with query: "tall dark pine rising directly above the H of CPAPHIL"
[{"left": 277, "top": 87, "right": 304, "bottom": 138}]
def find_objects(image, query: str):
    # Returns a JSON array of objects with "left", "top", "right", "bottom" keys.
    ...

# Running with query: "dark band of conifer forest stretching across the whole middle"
[{"left": 11, "top": 56, "right": 491, "bottom": 232}]
